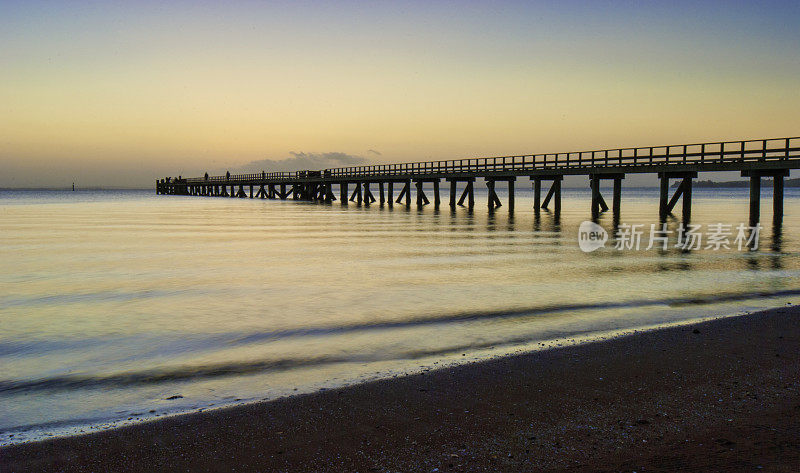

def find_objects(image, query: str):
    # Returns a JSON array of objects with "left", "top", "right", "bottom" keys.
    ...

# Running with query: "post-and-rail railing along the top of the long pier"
[{"left": 185, "top": 137, "right": 800, "bottom": 184}]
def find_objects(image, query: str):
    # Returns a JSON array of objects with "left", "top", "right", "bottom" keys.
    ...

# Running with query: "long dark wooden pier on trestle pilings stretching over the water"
[{"left": 156, "top": 137, "right": 800, "bottom": 225}]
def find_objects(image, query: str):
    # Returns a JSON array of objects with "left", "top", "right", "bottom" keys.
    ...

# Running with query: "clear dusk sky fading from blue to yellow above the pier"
[{"left": 0, "top": 0, "right": 800, "bottom": 187}]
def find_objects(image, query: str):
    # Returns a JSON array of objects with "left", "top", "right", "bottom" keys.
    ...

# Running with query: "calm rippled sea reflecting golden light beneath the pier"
[{"left": 0, "top": 189, "right": 800, "bottom": 444}]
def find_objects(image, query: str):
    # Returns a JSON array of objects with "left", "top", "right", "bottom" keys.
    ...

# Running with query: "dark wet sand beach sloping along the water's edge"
[{"left": 0, "top": 307, "right": 800, "bottom": 472}]
